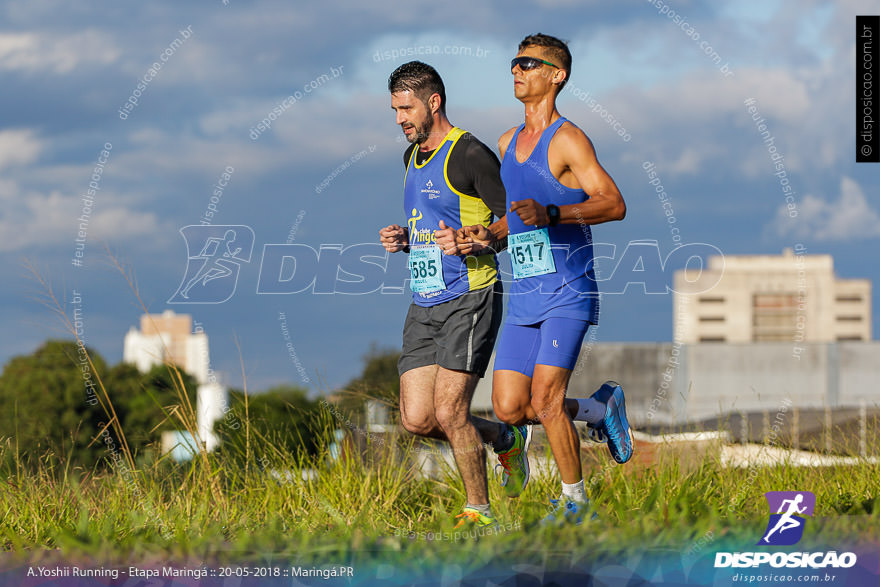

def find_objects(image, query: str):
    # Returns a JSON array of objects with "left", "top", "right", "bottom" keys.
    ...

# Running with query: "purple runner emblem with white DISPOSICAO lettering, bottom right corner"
[{"left": 715, "top": 491, "right": 857, "bottom": 569}]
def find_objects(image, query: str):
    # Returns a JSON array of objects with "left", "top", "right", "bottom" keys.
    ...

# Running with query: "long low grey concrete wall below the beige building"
[{"left": 472, "top": 341, "right": 880, "bottom": 427}]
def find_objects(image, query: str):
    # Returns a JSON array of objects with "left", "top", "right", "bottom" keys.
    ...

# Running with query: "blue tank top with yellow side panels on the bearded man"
[{"left": 403, "top": 128, "right": 498, "bottom": 306}]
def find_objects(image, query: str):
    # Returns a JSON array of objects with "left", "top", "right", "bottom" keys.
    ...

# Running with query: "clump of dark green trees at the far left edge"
[{"left": 0, "top": 340, "right": 196, "bottom": 468}]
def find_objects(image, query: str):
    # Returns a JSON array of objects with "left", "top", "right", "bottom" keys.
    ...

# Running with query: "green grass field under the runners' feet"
[{"left": 0, "top": 418, "right": 880, "bottom": 567}]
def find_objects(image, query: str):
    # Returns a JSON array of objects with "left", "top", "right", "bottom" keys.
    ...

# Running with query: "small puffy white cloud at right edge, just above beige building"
[{"left": 772, "top": 177, "right": 880, "bottom": 241}]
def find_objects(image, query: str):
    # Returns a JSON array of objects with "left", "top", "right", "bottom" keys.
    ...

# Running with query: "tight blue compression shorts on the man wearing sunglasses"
[{"left": 495, "top": 318, "right": 590, "bottom": 377}]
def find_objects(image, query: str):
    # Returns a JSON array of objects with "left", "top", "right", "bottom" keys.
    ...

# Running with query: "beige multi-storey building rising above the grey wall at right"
[{"left": 673, "top": 247, "right": 871, "bottom": 344}]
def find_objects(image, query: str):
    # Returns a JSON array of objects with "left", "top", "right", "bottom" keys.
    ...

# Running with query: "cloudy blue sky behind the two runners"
[{"left": 0, "top": 0, "right": 880, "bottom": 391}]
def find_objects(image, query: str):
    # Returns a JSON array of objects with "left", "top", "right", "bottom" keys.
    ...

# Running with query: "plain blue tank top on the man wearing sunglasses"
[{"left": 501, "top": 116, "right": 599, "bottom": 325}]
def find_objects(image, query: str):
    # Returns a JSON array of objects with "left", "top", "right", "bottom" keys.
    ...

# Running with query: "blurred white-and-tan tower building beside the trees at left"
[{"left": 122, "top": 310, "right": 228, "bottom": 450}]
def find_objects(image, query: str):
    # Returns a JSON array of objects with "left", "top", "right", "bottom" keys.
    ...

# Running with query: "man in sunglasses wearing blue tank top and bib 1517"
[{"left": 456, "top": 34, "right": 633, "bottom": 523}]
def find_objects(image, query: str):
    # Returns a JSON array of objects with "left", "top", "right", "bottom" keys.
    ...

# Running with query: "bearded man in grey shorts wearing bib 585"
[{"left": 379, "top": 61, "right": 531, "bottom": 527}]
